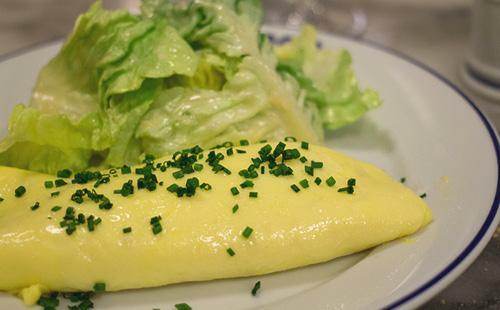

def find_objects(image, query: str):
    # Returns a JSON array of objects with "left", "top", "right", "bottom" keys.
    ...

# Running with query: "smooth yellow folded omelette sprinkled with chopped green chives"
[{"left": 0, "top": 141, "right": 432, "bottom": 304}]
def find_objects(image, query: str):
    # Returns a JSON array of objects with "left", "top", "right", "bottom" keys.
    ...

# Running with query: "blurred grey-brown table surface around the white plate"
[{"left": 0, "top": 0, "right": 500, "bottom": 309}]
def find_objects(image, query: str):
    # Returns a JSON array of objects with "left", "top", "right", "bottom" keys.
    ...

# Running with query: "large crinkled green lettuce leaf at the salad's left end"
[{"left": 0, "top": 1, "right": 198, "bottom": 173}]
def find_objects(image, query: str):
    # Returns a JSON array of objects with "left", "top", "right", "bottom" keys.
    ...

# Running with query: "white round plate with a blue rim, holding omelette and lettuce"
[{"left": 0, "top": 28, "right": 499, "bottom": 309}]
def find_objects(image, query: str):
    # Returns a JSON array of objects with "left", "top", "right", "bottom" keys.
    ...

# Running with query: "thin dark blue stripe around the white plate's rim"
[{"left": 0, "top": 30, "right": 500, "bottom": 309}]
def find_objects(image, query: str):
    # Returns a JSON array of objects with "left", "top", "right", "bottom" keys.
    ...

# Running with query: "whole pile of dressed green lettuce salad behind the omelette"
[{"left": 0, "top": 0, "right": 381, "bottom": 174}]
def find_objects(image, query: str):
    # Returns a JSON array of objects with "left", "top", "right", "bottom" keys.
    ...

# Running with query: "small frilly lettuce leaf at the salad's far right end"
[{"left": 276, "top": 26, "right": 382, "bottom": 129}]
